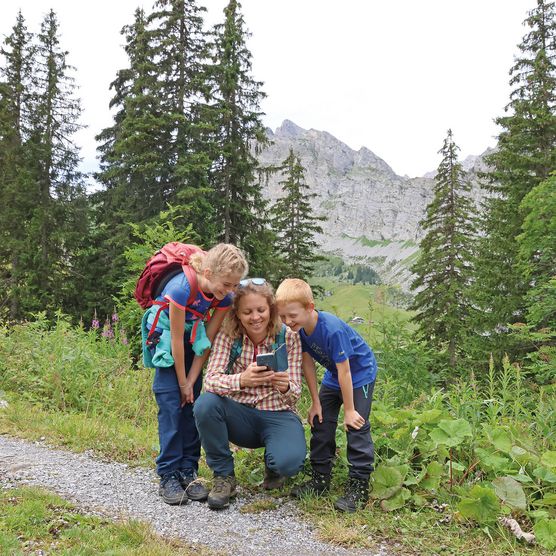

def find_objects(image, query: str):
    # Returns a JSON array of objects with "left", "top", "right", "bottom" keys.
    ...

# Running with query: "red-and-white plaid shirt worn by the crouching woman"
[{"left": 205, "top": 328, "right": 302, "bottom": 411}]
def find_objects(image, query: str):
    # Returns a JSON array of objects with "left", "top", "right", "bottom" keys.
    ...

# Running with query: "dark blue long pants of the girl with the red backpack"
[{"left": 153, "top": 340, "right": 203, "bottom": 477}]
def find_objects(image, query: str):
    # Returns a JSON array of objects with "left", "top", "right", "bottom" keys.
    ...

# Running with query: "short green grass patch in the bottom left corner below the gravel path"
[{"left": 0, "top": 487, "right": 210, "bottom": 556}]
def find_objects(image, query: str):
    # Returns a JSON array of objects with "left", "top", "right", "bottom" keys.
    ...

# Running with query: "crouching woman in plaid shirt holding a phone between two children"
[{"left": 194, "top": 278, "right": 306, "bottom": 509}]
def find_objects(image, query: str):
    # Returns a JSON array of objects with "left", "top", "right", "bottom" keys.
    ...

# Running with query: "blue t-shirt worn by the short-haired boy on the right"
[{"left": 299, "top": 311, "right": 377, "bottom": 390}]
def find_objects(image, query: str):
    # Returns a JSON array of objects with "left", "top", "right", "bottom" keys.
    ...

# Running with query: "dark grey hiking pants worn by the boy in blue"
[{"left": 311, "top": 382, "right": 375, "bottom": 480}]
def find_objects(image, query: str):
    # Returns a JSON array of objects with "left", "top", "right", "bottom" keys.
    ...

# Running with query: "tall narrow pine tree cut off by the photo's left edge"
[{"left": 0, "top": 12, "right": 36, "bottom": 320}]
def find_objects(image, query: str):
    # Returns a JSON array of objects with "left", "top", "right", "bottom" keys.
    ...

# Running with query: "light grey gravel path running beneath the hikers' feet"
[{"left": 0, "top": 435, "right": 385, "bottom": 556}]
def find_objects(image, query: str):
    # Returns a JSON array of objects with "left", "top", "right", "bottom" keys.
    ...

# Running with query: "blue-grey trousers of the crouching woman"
[{"left": 194, "top": 392, "right": 306, "bottom": 477}]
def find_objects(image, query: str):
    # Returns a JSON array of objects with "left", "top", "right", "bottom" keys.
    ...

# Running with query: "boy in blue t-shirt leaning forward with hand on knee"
[{"left": 276, "top": 278, "right": 377, "bottom": 512}]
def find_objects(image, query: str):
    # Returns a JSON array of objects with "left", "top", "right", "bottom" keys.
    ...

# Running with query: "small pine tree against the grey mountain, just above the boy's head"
[{"left": 271, "top": 148, "right": 326, "bottom": 280}]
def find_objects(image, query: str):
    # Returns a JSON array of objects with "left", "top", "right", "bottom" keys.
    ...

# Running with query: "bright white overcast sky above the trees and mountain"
[{"left": 0, "top": 0, "right": 536, "bottom": 176}]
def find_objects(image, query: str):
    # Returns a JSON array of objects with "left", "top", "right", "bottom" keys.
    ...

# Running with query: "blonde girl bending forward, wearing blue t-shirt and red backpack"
[{"left": 149, "top": 243, "right": 247, "bottom": 504}]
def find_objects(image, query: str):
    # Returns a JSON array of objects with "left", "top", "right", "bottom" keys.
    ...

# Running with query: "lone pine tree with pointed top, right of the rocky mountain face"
[{"left": 411, "top": 130, "right": 476, "bottom": 368}]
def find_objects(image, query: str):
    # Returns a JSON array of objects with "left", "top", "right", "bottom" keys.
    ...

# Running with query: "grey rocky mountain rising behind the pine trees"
[{"left": 258, "top": 120, "right": 490, "bottom": 286}]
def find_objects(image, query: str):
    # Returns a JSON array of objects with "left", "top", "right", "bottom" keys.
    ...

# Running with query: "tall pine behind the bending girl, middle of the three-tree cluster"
[{"left": 148, "top": 0, "right": 216, "bottom": 243}]
